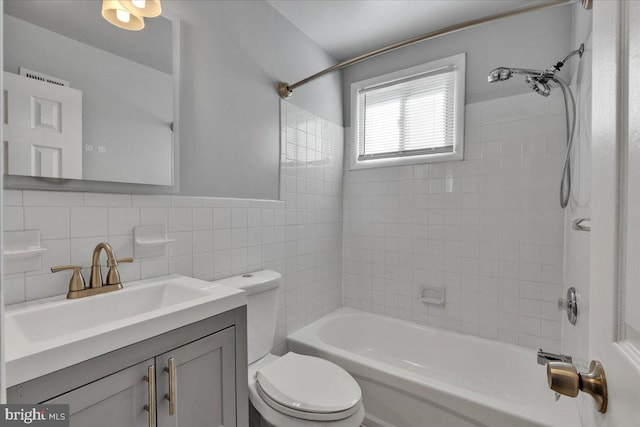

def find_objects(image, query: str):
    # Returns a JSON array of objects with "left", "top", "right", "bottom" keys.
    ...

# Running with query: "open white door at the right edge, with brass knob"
[{"left": 583, "top": 0, "right": 640, "bottom": 427}]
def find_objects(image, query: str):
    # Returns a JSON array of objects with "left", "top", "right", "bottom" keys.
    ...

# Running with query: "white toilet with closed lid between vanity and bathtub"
[{"left": 216, "top": 270, "right": 364, "bottom": 427}]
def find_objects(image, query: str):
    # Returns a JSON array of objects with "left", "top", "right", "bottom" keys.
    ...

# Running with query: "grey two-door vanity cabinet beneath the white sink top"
[{"left": 8, "top": 306, "right": 248, "bottom": 427}]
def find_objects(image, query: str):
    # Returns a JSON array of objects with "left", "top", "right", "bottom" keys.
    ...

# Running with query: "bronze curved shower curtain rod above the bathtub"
[{"left": 278, "top": 0, "right": 592, "bottom": 99}]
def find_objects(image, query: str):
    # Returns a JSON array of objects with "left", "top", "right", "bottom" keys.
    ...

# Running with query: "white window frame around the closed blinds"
[{"left": 349, "top": 53, "right": 466, "bottom": 169}]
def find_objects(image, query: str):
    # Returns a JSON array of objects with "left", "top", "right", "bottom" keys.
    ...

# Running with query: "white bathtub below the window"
[{"left": 287, "top": 308, "right": 580, "bottom": 427}]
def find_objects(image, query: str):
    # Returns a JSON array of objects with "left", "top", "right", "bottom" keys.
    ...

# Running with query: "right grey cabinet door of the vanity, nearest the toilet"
[{"left": 156, "top": 327, "right": 236, "bottom": 427}]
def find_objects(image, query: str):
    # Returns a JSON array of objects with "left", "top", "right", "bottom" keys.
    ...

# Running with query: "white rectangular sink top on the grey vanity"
[{"left": 5, "top": 275, "right": 246, "bottom": 386}]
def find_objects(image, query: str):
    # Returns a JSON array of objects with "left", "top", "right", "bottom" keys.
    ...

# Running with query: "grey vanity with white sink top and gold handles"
[{"left": 5, "top": 275, "right": 248, "bottom": 427}]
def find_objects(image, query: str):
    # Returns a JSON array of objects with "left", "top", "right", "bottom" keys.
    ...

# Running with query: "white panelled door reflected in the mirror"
[{"left": 3, "top": 72, "right": 82, "bottom": 179}]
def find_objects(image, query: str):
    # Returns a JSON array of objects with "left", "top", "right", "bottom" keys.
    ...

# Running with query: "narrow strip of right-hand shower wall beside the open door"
[{"left": 562, "top": 5, "right": 593, "bottom": 425}]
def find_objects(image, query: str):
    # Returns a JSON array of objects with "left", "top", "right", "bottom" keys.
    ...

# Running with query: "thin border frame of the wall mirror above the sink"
[{"left": 0, "top": 10, "right": 182, "bottom": 194}]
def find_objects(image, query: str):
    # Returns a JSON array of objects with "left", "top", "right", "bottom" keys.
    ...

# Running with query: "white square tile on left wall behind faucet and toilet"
[{"left": 3, "top": 103, "right": 344, "bottom": 351}]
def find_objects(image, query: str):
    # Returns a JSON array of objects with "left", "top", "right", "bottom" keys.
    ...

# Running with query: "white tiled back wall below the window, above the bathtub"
[{"left": 343, "top": 91, "right": 565, "bottom": 351}]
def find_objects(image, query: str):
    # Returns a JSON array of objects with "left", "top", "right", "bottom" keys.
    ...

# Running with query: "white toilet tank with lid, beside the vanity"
[{"left": 215, "top": 270, "right": 282, "bottom": 364}]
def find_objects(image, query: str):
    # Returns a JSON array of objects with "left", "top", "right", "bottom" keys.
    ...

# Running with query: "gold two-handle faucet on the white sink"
[{"left": 51, "top": 242, "right": 133, "bottom": 299}]
